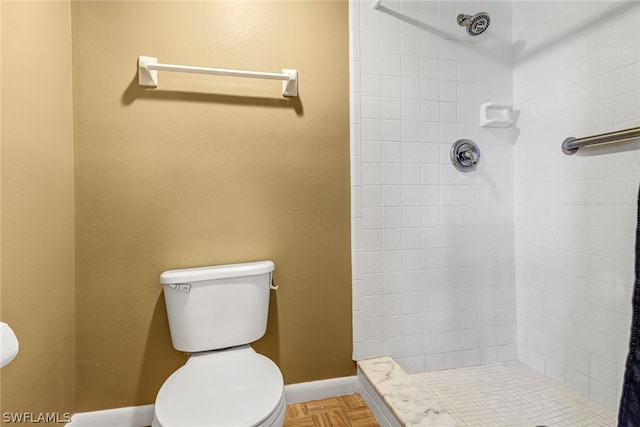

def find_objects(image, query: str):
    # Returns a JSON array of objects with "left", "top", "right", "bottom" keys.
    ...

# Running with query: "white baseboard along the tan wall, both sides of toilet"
[{"left": 66, "top": 375, "right": 359, "bottom": 427}]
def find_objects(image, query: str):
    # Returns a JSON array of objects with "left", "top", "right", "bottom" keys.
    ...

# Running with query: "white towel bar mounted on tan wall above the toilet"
[{"left": 138, "top": 56, "right": 298, "bottom": 96}]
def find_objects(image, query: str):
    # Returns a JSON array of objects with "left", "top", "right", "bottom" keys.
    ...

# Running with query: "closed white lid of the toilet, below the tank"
[{"left": 155, "top": 346, "right": 284, "bottom": 427}]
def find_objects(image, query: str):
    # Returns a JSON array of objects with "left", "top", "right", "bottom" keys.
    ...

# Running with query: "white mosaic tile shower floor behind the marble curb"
[{"left": 410, "top": 362, "right": 617, "bottom": 427}]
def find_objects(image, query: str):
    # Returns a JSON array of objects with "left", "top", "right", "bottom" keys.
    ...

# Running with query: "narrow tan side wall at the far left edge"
[{"left": 0, "top": 1, "right": 74, "bottom": 422}]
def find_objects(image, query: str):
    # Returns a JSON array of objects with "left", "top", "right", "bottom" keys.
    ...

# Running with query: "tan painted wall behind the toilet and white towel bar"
[{"left": 72, "top": 1, "right": 355, "bottom": 412}]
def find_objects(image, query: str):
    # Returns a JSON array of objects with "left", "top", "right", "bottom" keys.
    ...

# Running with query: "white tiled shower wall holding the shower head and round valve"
[{"left": 350, "top": 0, "right": 516, "bottom": 372}]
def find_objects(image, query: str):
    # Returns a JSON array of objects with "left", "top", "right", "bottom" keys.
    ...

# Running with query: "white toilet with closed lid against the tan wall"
[{"left": 152, "top": 261, "right": 286, "bottom": 427}]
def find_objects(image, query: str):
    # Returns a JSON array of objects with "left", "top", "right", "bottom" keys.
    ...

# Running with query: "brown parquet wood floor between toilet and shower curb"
[{"left": 284, "top": 393, "right": 380, "bottom": 427}]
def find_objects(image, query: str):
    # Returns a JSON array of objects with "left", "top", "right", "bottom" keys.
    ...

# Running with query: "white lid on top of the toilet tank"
[{"left": 160, "top": 261, "right": 275, "bottom": 285}]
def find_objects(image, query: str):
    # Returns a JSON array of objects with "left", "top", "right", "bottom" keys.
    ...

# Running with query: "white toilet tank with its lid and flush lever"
[{"left": 160, "top": 261, "right": 275, "bottom": 353}]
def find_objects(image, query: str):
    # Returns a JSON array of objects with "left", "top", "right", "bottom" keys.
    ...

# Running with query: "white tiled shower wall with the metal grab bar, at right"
[{"left": 513, "top": 1, "right": 640, "bottom": 408}]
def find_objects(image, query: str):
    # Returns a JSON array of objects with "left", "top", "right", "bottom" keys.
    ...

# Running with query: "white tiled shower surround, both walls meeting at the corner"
[{"left": 350, "top": 0, "right": 640, "bottom": 408}]
